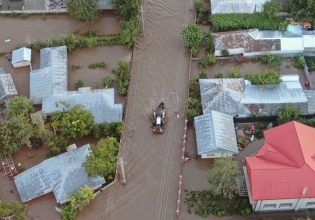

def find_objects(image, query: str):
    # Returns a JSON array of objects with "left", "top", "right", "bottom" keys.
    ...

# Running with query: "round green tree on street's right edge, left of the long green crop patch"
[{"left": 182, "top": 23, "right": 203, "bottom": 55}]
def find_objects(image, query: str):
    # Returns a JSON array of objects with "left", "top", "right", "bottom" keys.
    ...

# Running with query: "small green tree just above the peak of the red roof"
[{"left": 277, "top": 105, "right": 302, "bottom": 124}]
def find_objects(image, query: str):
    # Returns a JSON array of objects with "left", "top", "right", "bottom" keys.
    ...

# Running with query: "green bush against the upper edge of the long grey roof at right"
[{"left": 246, "top": 69, "right": 281, "bottom": 85}]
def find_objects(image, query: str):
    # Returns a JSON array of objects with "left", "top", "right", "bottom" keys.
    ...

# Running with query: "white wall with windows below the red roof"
[{"left": 253, "top": 198, "right": 315, "bottom": 212}]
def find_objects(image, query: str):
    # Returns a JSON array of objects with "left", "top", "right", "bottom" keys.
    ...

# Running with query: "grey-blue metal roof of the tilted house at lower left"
[{"left": 14, "top": 144, "right": 105, "bottom": 203}]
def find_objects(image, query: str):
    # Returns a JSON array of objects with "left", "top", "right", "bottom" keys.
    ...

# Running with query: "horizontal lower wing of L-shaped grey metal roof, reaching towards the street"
[{"left": 42, "top": 88, "right": 123, "bottom": 123}]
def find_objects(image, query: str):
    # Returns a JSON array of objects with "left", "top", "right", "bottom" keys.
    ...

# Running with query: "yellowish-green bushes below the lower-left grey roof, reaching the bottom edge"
[{"left": 60, "top": 185, "right": 94, "bottom": 220}]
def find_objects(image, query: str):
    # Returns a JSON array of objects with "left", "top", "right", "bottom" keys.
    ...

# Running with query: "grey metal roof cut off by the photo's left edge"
[{"left": 0, "top": 68, "right": 18, "bottom": 100}]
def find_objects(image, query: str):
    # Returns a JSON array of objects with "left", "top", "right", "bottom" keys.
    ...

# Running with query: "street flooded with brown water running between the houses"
[{"left": 78, "top": 0, "right": 193, "bottom": 220}]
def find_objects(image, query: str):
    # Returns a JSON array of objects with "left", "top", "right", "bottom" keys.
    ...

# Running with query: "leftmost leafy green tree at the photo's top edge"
[{"left": 67, "top": 0, "right": 100, "bottom": 22}]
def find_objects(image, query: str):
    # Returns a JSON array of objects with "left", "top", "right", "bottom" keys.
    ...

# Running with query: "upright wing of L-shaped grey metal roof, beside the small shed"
[{"left": 30, "top": 46, "right": 68, "bottom": 103}]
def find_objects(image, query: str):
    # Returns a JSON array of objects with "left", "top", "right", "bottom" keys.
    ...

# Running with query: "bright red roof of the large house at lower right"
[{"left": 246, "top": 121, "right": 315, "bottom": 200}]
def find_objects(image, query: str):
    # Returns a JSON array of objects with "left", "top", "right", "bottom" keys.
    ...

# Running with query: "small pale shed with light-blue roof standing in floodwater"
[{"left": 11, "top": 47, "right": 32, "bottom": 68}]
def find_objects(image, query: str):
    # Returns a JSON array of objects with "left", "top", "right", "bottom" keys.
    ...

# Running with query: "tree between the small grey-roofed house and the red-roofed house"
[{"left": 208, "top": 157, "right": 239, "bottom": 198}]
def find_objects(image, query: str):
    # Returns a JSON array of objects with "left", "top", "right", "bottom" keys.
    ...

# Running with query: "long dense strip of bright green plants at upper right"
[{"left": 212, "top": 13, "right": 289, "bottom": 32}]
